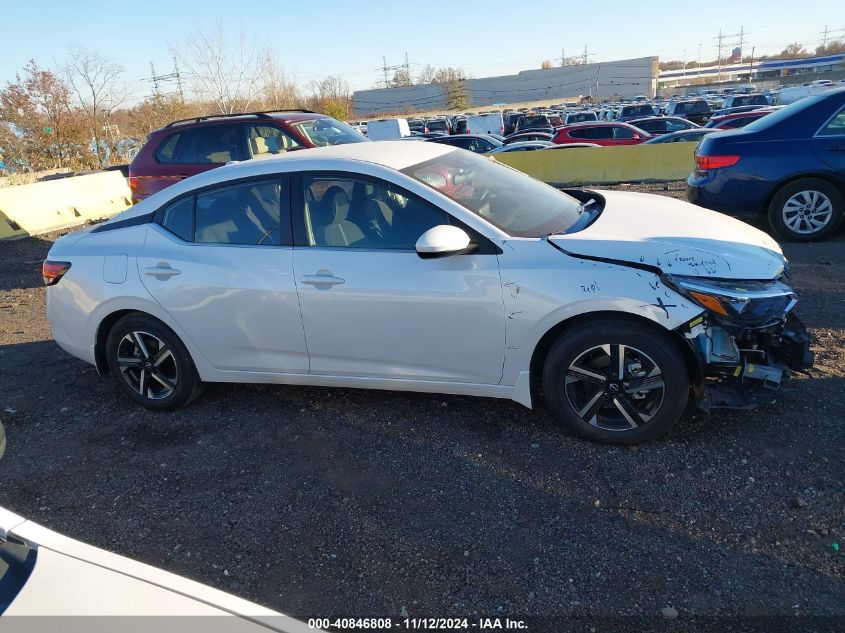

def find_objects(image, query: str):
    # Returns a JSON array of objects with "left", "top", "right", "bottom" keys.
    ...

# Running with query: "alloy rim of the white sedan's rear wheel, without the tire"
[{"left": 117, "top": 331, "right": 179, "bottom": 400}]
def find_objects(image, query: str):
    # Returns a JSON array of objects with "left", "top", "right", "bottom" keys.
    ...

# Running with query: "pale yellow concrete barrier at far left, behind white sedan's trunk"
[{"left": 0, "top": 171, "right": 132, "bottom": 239}]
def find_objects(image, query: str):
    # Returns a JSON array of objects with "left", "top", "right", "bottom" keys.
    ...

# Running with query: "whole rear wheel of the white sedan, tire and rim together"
[{"left": 106, "top": 314, "right": 201, "bottom": 411}]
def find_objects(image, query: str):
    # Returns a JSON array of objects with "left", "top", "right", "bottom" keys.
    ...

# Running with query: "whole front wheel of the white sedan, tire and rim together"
[{"left": 543, "top": 318, "right": 689, "bottom": 444}]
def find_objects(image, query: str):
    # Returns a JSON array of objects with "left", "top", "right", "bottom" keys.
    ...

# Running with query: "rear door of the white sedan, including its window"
[{"left": 138, "top": 176, "right": 308, "bottom": 373}]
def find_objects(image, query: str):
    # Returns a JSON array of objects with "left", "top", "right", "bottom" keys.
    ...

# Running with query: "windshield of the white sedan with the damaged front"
[{"left": 402, "top": 151, "right": 581, "bottom": 237}]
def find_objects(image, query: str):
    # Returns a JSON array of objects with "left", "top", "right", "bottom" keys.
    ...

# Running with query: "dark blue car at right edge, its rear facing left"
[{"left": 687, "top": 89, "right": 845, "bottom": 242}]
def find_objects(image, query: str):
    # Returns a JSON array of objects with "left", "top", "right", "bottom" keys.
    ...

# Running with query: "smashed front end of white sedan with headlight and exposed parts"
[{"left": 663, "top": 275, "right": 813, "bottom": 410}]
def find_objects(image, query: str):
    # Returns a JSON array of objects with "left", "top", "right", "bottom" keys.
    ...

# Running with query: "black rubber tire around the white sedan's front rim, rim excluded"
[{"left": 543, "top": 319, "right": 689, "bottom": 444}]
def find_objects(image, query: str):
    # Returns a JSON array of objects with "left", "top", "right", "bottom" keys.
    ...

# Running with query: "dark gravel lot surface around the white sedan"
[{"left": 0, "top": 180, "right": 845, "bottom": 631}]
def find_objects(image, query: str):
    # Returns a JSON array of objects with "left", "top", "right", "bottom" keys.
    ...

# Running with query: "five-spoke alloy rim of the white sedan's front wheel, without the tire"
[{"left": 564, "top": 344, "right": 666, "bottom": 431}]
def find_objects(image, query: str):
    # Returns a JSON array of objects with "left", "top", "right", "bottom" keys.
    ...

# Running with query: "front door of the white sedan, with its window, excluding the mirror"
[{"left": 293, "top": 173, "right": 505, "bottom": 384}]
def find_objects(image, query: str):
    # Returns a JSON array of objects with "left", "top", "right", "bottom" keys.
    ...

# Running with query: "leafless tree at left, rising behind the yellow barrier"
[{"left": 65, "top": 47, "right": 129, "bottom": 167}]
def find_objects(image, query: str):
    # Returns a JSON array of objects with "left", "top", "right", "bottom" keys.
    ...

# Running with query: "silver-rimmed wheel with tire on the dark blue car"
[{"left": 768, "top": 178, "right": 845, "bottom": 242}]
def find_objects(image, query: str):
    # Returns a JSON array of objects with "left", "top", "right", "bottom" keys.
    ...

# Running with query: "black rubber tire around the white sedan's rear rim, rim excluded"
[{"left": 106, "top": 314, "right": 199, "bottom": 411}]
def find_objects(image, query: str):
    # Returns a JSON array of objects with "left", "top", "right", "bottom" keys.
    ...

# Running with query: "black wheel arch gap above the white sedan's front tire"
[{"left": 528, "top": 310, "right": 704, "bottom": 406}]
